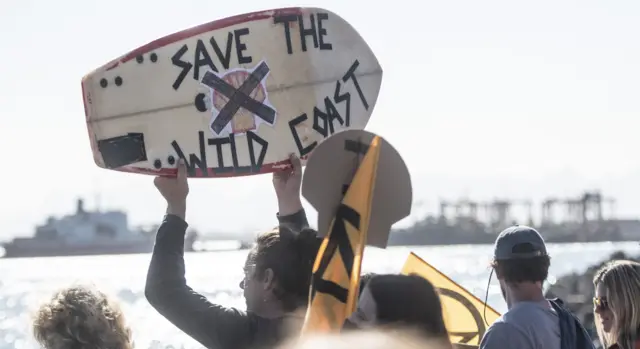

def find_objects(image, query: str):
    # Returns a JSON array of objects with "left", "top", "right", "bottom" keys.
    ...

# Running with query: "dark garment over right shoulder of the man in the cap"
[{"left": 549, "top": 298, "right": 595, "bottom": 349}]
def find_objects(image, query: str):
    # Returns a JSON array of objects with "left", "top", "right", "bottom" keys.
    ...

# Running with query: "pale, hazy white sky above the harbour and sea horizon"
[{"left": 0, "top": 0, "right": 640, "bottom": 240}]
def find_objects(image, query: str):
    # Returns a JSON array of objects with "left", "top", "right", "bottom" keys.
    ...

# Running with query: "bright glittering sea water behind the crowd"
[{"left": 0, "top": 242, "right": 640, "bottom": 349}]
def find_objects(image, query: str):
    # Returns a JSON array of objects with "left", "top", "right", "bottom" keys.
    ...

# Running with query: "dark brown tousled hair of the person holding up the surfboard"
[{"left": 249, "top": 225, "right": 322, "bottom": 311}]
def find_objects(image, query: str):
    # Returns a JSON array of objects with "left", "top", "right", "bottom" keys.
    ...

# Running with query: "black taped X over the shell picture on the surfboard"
[{"left": 202, "top": 62, "right": 276, "bottom": 134}]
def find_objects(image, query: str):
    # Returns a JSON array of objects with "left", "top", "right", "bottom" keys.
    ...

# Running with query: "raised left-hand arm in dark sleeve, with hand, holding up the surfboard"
[{"left": 145, "top": 163, "right": 255, "bottom": 349}]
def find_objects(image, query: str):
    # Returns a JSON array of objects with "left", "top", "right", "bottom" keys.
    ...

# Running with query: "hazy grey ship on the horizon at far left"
[{"left": 2, "top": 199, "right": 196, "bottom": 258}]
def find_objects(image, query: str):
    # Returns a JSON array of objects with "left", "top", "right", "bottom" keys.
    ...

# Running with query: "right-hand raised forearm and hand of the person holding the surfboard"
[{"left": 273, "top": 154, "right": 309, "bottom": 231}]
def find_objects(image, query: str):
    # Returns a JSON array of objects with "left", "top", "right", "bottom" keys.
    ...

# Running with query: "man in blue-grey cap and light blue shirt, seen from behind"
[{"left": 480, "top": 225, "right": 594, "bottom": 349}]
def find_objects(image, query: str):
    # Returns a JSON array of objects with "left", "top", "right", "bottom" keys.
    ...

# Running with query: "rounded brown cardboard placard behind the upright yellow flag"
[{"left": 302, "top": 130, "right": 412, "bottom": 248}]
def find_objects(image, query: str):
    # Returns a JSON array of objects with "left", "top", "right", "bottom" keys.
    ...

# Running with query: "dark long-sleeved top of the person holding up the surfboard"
[{"left": 145, "top": 210, "right": 308, "bottom": 349}]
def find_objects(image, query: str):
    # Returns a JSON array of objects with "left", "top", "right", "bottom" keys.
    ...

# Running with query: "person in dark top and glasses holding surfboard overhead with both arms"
[{"left": 145, "top": 156, "right": 322, "bottom": 349}]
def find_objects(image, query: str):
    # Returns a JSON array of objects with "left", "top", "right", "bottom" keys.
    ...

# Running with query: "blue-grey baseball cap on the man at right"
[{"left": 493, "top": 225, "right": 547, "bottom": 260}]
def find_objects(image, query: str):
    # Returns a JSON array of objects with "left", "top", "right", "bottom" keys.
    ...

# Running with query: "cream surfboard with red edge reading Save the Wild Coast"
[{"left": 82, "top": 8, "right": 382, "bottom": 177}]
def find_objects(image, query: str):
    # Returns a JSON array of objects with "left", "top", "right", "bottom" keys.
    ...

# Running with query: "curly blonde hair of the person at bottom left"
[{"left": 33, "top": 285, "right": 133, "bottom": 349}]
